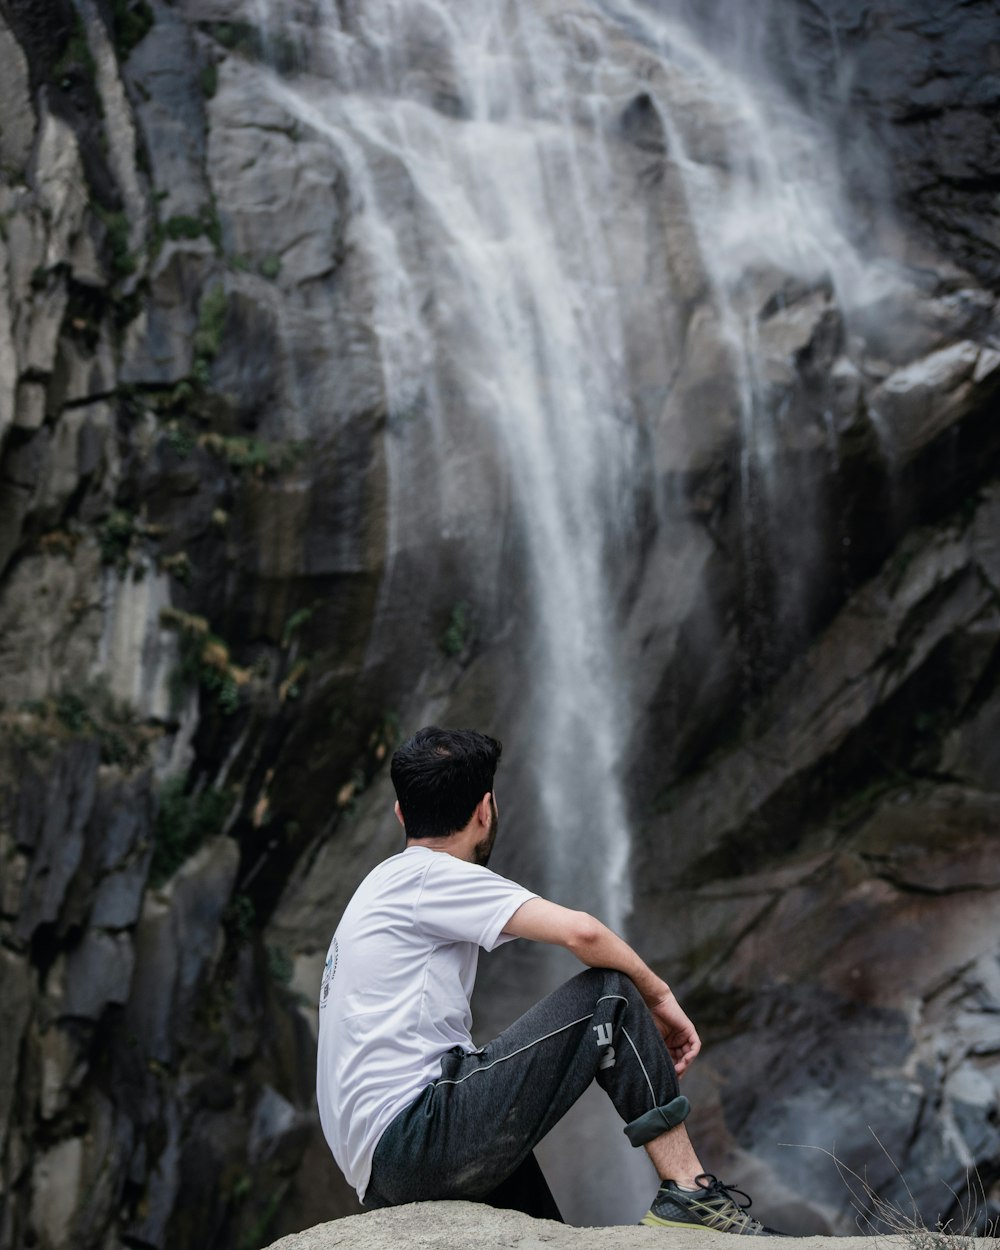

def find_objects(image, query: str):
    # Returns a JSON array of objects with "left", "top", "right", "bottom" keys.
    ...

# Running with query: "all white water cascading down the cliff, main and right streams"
[{"left": 247, "top": 0, "right": 891, "bottom": 1223}]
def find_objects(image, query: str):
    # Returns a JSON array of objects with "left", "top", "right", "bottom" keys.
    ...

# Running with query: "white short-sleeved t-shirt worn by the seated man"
[{"left": 316, "top": 846, "right": 536, "bottom": 1201}]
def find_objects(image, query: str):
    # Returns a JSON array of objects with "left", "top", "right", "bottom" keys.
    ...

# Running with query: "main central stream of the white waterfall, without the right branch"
[{"left": 265, "top": 3, "right": 639, "bottom": 929}]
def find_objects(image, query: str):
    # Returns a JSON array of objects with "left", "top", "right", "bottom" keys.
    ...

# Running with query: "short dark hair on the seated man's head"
[{"left": 389, "top": 725, "right": 503, "bottom": 838}]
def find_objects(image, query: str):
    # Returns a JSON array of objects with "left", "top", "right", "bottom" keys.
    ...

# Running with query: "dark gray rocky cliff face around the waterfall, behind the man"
[{"left": 0, "top": 0, "right": 1000, "bottom": 1248}]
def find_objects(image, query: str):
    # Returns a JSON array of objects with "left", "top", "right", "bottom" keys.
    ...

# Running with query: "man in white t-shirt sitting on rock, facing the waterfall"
[{"left": 318, "top": 726, "right": 770, "bottom": 1235}]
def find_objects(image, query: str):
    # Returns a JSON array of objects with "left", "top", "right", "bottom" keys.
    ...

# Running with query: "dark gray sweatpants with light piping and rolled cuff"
[{"left": 365, "top": 968, "right": 688, "bottom": 1206}]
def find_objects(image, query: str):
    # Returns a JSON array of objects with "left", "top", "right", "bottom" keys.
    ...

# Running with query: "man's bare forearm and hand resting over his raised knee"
[{"left": 504, "top": 899, "right": 701, "bottom": 1076}]
